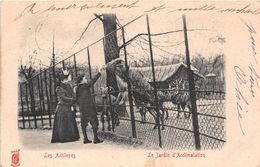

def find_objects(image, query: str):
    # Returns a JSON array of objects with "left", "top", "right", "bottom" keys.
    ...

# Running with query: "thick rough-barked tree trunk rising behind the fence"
[{"left": 102, "top": 14, "right": 119, "bottom": 95}]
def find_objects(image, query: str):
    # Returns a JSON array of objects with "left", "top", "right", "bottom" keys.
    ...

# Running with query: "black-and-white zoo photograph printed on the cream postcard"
[{"left": 18, "top": 13, "right": 226, "bottom": 149}]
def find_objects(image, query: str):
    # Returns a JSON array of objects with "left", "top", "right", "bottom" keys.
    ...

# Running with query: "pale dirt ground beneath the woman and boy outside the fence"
[{"left": 19, "top": 124, "right": 150, "bottom": 150}]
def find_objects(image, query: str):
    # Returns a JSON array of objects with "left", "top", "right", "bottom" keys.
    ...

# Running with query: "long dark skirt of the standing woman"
[{"left": 51, "top": 105, "right": 79, "bottom": 143}]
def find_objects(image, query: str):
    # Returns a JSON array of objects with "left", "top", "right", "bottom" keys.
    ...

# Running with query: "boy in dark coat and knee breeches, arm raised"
[{"left": 76, "top": 68, "right": 103, "bottom": 144}]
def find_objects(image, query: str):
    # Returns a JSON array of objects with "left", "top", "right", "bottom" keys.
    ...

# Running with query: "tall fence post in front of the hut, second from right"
[{"left": 146, "top": 15, "right": 162, "bottom": 147}]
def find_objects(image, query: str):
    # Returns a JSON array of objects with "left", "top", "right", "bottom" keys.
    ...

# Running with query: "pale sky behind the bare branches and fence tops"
[{"left": 19, "top": 9, "right": 225, "bottom": 67}]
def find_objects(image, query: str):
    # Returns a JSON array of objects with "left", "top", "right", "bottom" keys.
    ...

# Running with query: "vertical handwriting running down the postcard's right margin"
[{"left": 234, "top": 20, "right": 260, "bottom": 134}]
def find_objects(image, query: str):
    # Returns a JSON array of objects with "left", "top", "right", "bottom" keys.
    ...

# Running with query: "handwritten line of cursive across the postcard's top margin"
[{"left": 14, "top": 1, "right": 260, "bottom": 21}]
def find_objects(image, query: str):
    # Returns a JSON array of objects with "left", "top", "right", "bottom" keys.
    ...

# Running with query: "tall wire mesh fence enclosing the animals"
[{"left": 19, "top": 14, "right": 225, "bottom": 149}]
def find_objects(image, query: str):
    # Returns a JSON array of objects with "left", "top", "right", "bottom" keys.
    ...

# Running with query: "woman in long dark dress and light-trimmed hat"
[{"left": 51, "top": 71, "right": 79, "bottom": 143}]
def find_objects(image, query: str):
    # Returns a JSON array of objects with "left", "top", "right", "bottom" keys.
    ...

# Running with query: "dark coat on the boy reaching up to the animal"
[{"left": 76, "top": 73, "right": 101, "bottom": 118}]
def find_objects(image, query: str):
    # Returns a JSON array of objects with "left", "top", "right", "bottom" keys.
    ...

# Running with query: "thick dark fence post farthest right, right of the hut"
[{"left": 182, "top": 15, "right": 201, "bottom": 150}]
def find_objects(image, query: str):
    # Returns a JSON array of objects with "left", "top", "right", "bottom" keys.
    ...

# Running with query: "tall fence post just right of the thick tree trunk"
[{"left": 122, "top": 27, "right": 137, "bottom": 138}]
